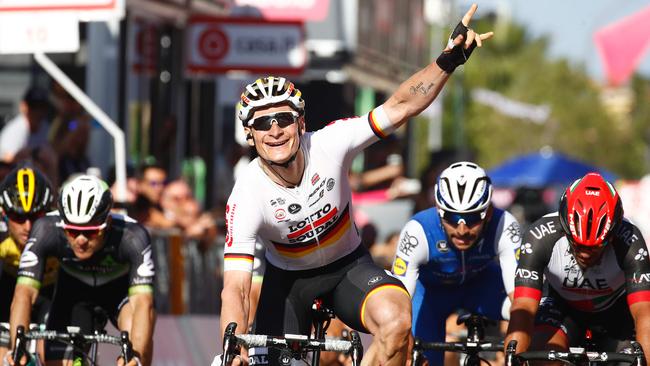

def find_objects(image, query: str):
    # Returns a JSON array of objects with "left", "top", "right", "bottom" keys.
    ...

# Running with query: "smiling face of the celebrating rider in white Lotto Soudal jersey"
[{"left": 246, "top": 105, "right": 304, "bottom": 164}]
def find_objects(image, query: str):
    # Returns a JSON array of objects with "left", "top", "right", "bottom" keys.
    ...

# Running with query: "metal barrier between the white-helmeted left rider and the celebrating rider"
[{"left": 149, "top": 229, "right": 224, "bottom": 315}]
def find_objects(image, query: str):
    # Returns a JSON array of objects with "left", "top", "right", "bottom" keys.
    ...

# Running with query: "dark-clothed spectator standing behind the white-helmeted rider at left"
[{"left": 48, "top": 84, "right": 92, "bottom": 182}]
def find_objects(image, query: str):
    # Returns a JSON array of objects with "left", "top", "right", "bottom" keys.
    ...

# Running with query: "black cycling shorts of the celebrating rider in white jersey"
[{"left": 253, "top": 245, "right": 406, "bottom": 335}]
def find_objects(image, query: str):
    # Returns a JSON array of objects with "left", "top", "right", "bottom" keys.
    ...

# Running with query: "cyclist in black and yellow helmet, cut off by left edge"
[{"left": 0, "top": 164, "right": 58, "bottom": 359}]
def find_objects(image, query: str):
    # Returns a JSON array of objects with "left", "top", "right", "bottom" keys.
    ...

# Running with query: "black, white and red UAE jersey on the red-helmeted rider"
[{"left": 515, "top": 212, "right": 650, "bottom": 312}]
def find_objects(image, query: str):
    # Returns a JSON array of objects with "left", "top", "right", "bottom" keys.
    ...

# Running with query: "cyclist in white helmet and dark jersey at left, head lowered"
[{"left": 11, "top": 175, "right": 155, "bottom": 365}]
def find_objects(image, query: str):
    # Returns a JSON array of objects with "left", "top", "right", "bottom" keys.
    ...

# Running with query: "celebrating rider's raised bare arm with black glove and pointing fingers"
[{"left": 383, "top": 4, "right": 493, "bottom": 128}]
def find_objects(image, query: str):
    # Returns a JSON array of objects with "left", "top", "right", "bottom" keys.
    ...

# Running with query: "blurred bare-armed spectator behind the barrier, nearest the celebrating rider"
[{"left": 160, "top": 179, "right": 217, "bottom": 249}]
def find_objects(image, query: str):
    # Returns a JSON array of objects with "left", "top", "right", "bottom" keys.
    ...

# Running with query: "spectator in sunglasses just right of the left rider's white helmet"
[{"left": 129, "top": 163, "right": 174, "bottom": 229}]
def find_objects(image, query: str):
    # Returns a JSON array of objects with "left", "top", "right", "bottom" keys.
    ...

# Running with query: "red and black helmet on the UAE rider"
[{"left": 559, "top": 173, "right": 623, "bottom": 246}]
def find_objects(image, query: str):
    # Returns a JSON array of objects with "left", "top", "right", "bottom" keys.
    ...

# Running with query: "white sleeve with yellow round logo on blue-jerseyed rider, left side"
[{"left": 392, "top": 220, "right": 429, "bottom": 297}]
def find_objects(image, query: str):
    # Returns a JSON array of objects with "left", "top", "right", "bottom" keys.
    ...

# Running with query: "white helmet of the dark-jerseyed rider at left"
[{"left": 59, "top": 175, "right": 113, "bottom": 229}]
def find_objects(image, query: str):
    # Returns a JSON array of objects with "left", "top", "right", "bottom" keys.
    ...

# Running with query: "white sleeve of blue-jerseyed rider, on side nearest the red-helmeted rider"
[{"left": 495, "top": 211, "right": 522, "bottom": 294}]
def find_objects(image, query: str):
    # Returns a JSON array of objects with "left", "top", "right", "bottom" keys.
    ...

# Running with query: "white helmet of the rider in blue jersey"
[{"left": 435, "top": 161, "right": 492, "bottom": 213}]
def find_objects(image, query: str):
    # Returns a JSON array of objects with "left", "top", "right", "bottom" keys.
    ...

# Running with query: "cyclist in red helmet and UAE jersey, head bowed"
[{"left": 506, "top": 173, "right": 650, "bottom": 358}]
